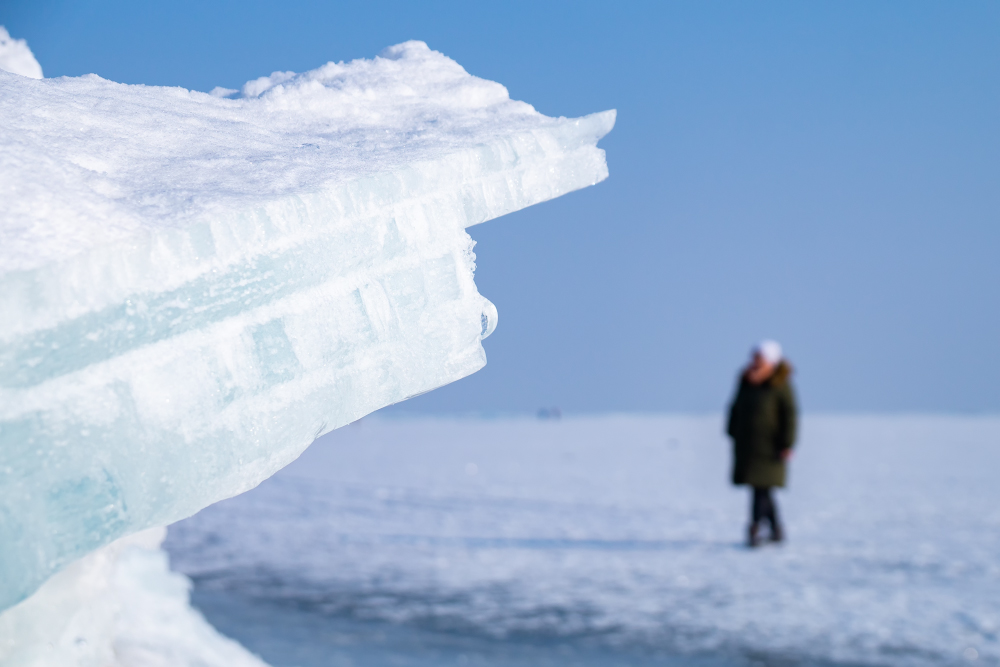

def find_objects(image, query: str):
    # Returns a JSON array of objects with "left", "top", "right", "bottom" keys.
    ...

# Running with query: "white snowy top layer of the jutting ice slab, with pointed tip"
[{"left": 0, "top": 42, "right": 614, "bottom": 276}]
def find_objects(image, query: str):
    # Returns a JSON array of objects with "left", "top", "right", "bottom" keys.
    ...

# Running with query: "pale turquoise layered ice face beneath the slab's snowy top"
[{"left": 0, "top": 209, "right": 495, "bottom": 603}]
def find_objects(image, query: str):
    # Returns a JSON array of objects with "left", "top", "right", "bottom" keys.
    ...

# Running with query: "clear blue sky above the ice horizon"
[{"left": 0, "top": 0, "right": 1000, "bottom": 413}]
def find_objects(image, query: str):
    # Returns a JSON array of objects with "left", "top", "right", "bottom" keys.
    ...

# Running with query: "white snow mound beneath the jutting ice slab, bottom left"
[{"left": 0, "top": 528, "right": 265, "bottom": 667}]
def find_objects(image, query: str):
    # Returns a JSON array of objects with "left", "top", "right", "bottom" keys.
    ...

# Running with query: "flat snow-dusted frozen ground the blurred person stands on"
[{"left": 166, "top": 415, "right": 1000, "bottom": 667}]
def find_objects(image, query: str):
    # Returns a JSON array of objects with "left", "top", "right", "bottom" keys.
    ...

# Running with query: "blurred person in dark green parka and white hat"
[{"left": 726, "top": 340, "right": 798, "bottom": 547}]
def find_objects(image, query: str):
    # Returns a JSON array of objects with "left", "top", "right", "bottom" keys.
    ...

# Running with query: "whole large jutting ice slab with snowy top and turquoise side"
[{"left": 0, "top": 42, "right": 614, "bottom": 609}]
